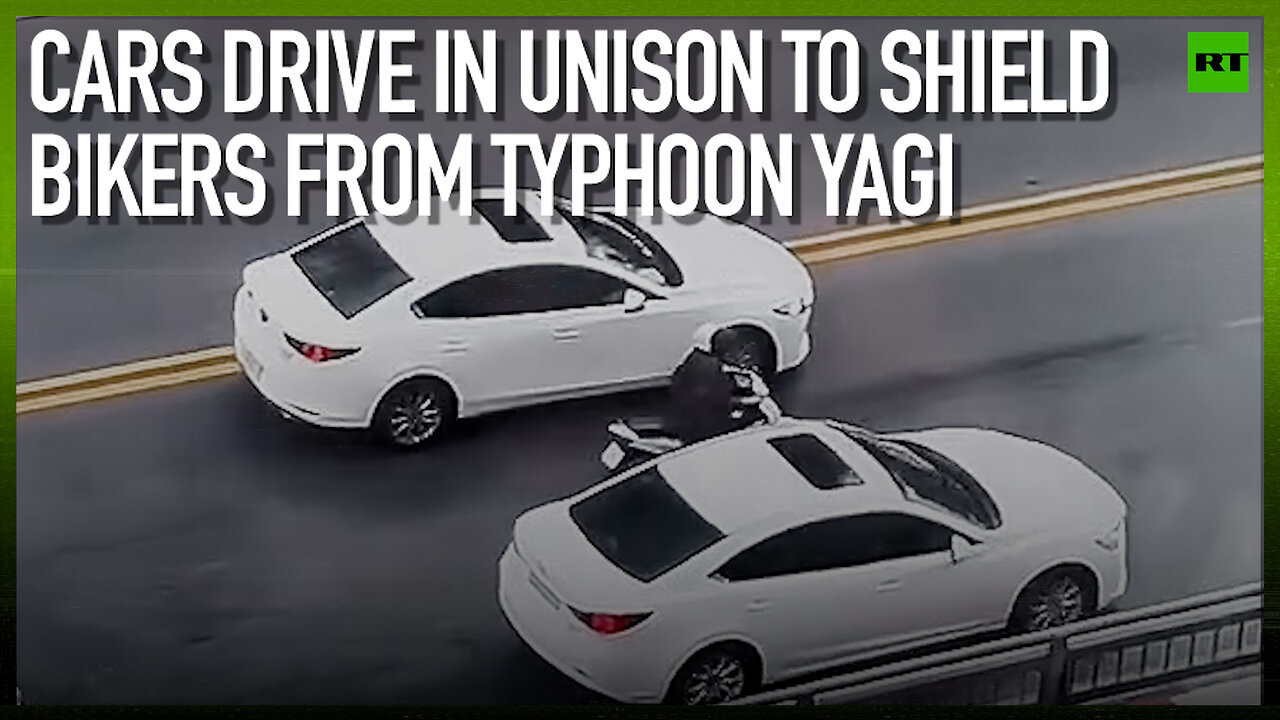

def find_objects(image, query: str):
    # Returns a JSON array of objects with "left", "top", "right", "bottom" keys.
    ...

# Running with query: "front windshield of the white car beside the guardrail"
[{"left": 836, "top": 424, "right": 1000, "bottom": 530}]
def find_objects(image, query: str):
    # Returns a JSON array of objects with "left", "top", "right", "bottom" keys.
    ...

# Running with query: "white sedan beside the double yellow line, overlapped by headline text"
[{"left": 234, "top": 190, "right": 814, "bottom": 447}]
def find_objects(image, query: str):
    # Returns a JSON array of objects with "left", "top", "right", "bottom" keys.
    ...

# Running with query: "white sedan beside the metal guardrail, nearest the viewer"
[{"left": 498, "top": 419, "right": 1128, "bottom": 705}]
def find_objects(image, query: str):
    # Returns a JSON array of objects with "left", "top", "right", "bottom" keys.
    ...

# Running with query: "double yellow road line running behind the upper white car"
[{"left": 18, "top": 155, "right": 1262, "bottom": 415}]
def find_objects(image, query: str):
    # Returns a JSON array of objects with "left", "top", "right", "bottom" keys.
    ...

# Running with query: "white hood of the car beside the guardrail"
[{"left": 891, "top": 428, "right": 1126, "bottom": 533}]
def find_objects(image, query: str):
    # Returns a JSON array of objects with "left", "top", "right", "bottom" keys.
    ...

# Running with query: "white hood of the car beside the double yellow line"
[{"left": 631, "top": 213, "right": 813, "bottom": 297}]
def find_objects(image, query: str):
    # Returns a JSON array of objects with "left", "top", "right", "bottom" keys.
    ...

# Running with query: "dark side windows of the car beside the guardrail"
[{"left": 717, "top": 512, "right": 952, "bottom": 582}]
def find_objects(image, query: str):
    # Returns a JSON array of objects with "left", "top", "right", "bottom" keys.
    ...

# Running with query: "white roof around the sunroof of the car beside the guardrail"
[{"left": 658, "top": 419, "right": 908, "bottom": 534}]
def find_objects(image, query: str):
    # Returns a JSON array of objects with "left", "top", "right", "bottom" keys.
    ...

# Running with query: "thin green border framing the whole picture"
[{"left": 0, "top": 0, "right": 1280, "bottom": 717}]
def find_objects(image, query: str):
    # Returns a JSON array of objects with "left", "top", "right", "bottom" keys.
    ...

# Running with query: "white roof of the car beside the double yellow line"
[{"left": 365, "top": 187, "right": 588, "bottom": 286}]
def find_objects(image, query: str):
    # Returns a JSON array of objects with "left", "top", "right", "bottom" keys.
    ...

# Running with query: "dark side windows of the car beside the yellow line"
[{"left": 416, "top": 265, "right": 628, "bottom": 318}]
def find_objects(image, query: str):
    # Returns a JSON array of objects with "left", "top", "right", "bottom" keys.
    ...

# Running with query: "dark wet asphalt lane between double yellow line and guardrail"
[{"left": 17, "top": 187, "right": 1262, "bottom": 703}]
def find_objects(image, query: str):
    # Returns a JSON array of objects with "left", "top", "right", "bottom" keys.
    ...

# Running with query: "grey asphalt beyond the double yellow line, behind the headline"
[{"left": 17, "top": 18, "right": 1262, "bottom": 379}]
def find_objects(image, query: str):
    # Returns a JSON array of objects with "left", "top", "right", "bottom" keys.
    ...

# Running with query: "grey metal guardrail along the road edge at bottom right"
[{"left": 735, "top": 583, "right": 1262, "bottom": 705}]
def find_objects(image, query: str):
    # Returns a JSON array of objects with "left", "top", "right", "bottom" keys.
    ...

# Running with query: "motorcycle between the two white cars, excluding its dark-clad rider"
[{"left": 600, "top": 365, "right": 782, "bottom": 471}]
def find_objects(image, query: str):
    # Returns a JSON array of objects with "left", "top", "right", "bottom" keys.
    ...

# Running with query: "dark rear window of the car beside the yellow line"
[{"left": 293, "top": 223, "right": 410, "bottom": 319}]
